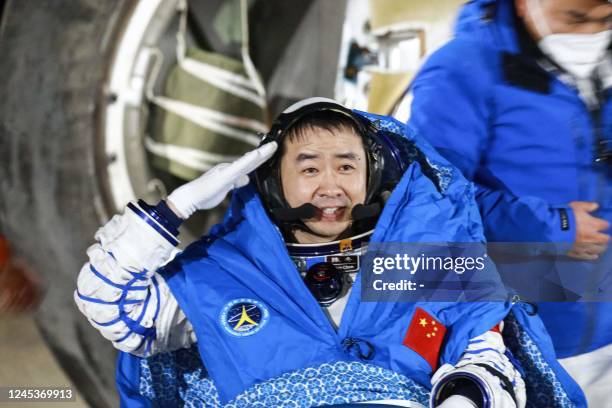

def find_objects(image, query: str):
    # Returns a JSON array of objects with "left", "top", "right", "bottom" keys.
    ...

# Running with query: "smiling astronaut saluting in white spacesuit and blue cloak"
[{"left": 75, "top": 98, "right": 584, "bottom": 408}]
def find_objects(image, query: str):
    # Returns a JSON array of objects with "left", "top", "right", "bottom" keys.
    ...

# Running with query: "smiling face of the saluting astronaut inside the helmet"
[{"left": 280, "top": 127, "right": 367, "bottom": 243}]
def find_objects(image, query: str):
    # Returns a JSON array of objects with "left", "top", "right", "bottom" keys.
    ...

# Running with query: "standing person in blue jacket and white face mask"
[{"left": 406, "top": 0, "right": 612, "bottom": 407}]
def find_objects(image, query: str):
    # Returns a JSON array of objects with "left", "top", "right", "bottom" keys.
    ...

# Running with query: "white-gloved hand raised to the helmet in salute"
[{"left": 167, "top": 142, "right": 278, "bottom": 219}]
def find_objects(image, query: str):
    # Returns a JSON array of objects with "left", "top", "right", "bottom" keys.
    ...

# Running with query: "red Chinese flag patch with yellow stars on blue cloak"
[{"left": 402, "top": 307, "right": 446, "bottom": 371}]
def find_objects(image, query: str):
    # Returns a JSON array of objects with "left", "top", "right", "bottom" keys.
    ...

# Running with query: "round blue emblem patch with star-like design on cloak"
[{"left": 219, "top": 298, "right": 270, "bottom": 337}]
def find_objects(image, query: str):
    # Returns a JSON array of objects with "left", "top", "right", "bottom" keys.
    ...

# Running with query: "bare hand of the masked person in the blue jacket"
[{"left": 567, "top": 201, "right": 610, "bottom": 261}]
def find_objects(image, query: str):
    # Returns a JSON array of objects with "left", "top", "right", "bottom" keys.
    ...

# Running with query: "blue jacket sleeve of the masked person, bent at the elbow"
[{"left": 409, "top": 39, "right": 575, "bottom": 242}]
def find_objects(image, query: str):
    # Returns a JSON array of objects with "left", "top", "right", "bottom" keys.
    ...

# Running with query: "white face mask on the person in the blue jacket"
[{"left": 527, "top": 0, "right": 612, "bottom": 78}]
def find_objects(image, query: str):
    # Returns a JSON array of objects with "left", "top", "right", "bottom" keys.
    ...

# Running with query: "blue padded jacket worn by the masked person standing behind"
[{"left": 410, "top": 0, "right": 612, "bottom": 357}]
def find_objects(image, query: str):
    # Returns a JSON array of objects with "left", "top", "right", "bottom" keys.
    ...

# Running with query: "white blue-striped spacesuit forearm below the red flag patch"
[{"left": 430, "top": 331, "right": 527, "bottom": 408}]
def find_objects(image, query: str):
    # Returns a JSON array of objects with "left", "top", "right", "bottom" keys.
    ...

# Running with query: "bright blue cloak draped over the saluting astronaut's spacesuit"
[{"left": 113, "top": 116, "right": 584, "bottom": 406}]
